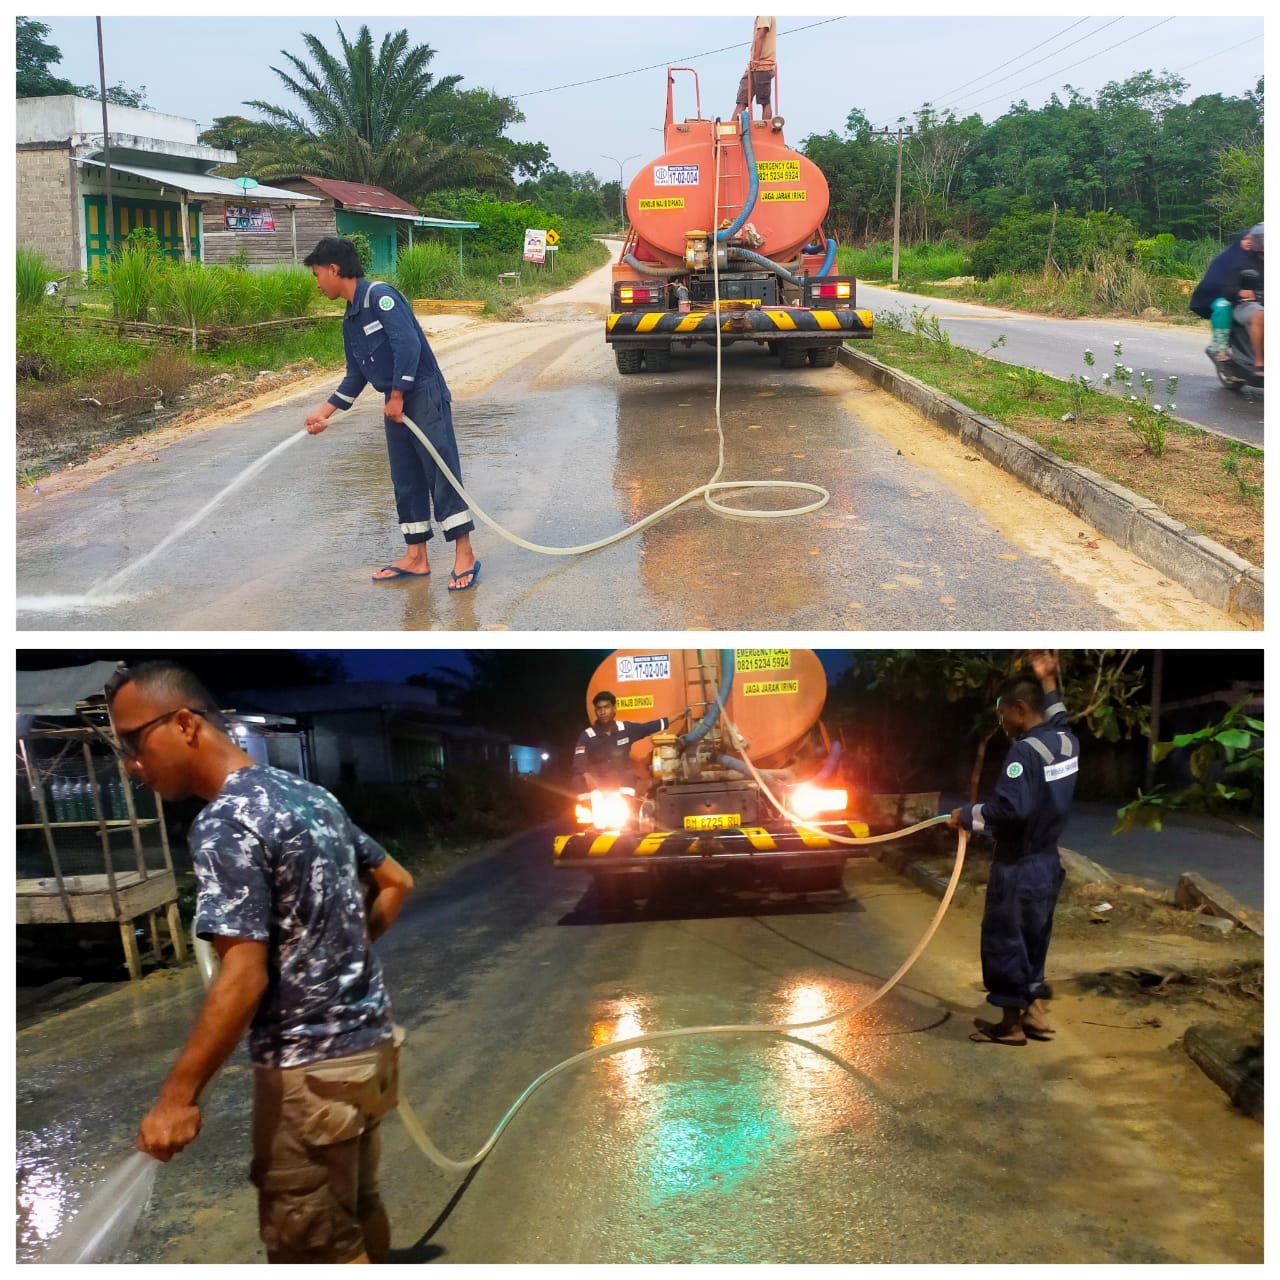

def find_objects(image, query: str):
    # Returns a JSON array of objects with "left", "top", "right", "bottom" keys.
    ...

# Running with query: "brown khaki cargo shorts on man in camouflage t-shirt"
[{"left": 250, "top": 1039, "right": 399, "bottom": 1262}]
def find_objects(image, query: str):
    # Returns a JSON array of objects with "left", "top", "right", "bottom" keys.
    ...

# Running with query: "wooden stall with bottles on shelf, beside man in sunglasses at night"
[{"left": 15, "top": 662, "right": 187, "bottom": 979}]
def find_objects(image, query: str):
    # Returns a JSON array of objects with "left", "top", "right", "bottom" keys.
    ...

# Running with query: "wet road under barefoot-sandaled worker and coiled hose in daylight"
[{"left": 10, "top": 296, "right": 1233, "bottom": 631}]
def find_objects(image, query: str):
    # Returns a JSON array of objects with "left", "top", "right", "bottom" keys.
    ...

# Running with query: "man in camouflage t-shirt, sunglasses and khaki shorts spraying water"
[{"left": 109, "top": 663, "right": 413, "bottom": 1262}]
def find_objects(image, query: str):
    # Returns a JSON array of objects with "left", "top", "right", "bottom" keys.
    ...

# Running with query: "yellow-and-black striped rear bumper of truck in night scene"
[{"left": 554, "top": 822, "right": 870, "bottom": 868}]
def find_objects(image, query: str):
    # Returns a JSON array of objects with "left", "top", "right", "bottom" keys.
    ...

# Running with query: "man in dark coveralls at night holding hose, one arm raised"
[{"left": 950, "top": 649, "right": 1080, "bottom": 1044}]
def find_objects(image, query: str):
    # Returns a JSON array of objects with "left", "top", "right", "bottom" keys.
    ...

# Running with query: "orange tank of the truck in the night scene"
[{"left": 586, "top": 648, "right": 827, "bottom": 768}]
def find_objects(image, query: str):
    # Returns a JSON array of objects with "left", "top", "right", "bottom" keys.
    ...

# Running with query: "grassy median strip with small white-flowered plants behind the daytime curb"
[{"left": 855, "top": 315, "right": 1263, "bottom": 564}]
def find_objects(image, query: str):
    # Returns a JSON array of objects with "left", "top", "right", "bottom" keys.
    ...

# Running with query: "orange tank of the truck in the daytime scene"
[{"left": 627, "top": 120, "right": 831, "bottom": 266}]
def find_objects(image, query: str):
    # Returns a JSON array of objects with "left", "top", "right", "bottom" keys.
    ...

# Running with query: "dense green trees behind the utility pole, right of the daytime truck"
[{"left": 801, "top": 70, "right": 1263, "bottom": 242}]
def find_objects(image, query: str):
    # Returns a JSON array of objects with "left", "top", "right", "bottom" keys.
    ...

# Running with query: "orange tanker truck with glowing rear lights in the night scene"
[{"left": 554, "top": 649, "right": 868, "bottom": 902}]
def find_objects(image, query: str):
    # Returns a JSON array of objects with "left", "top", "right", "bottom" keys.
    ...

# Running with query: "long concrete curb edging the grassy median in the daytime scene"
[{"left": 840, "top": 347, "right": 1263, "bottom": 630}]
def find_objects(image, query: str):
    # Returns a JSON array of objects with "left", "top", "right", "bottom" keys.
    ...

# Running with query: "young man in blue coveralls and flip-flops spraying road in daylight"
[{"left": 302, "top": 237, "right": 480, "bottom": 591}]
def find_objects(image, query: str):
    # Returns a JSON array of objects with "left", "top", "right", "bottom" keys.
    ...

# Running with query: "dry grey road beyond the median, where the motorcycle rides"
[{"left": 858, "top": 283, "right": 1263, "bottom": 448}]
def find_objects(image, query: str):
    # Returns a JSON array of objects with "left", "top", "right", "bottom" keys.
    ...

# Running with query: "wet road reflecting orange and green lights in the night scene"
[{"left": 17, "top": 833, "right": 1262, "bottom": 1263}]
